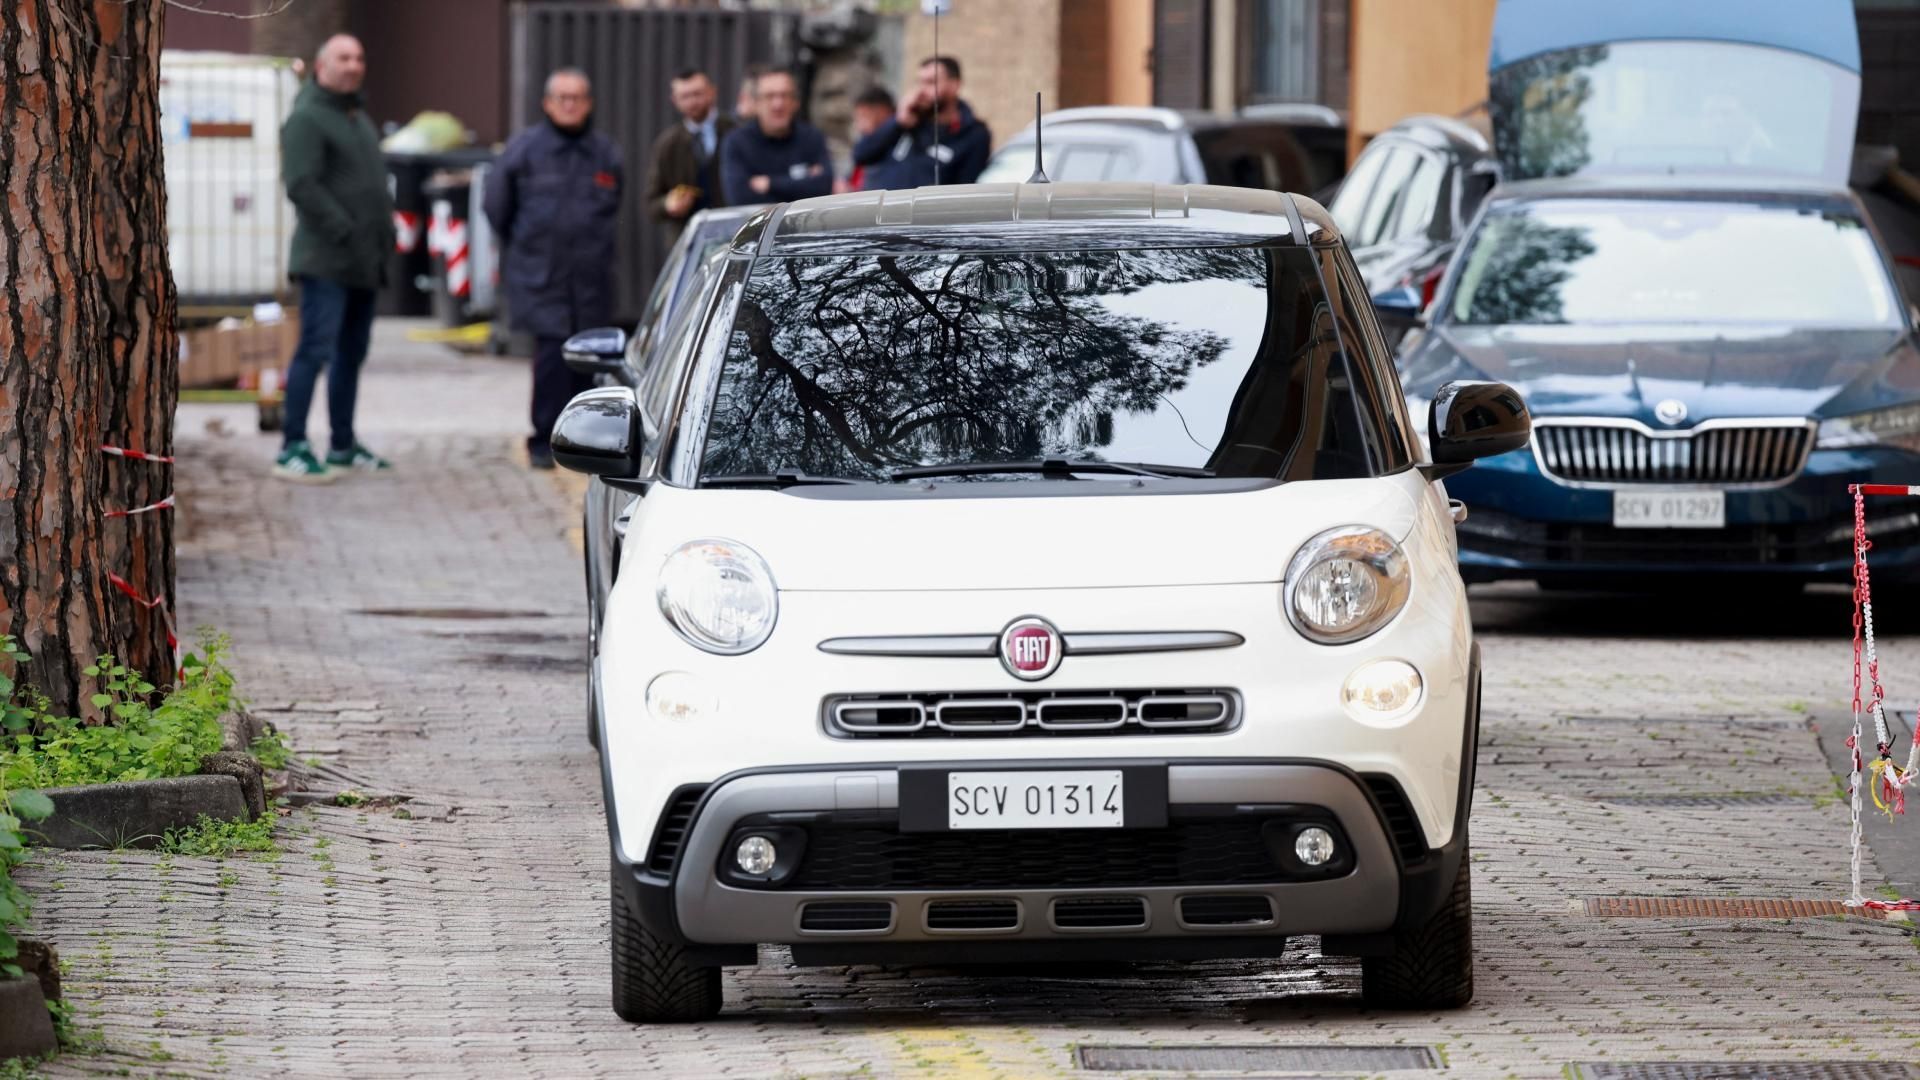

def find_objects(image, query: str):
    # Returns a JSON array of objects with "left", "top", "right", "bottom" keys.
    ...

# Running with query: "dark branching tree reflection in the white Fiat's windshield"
[{"left": 703, "top": 248, "right": 1267, "bottom": 475}]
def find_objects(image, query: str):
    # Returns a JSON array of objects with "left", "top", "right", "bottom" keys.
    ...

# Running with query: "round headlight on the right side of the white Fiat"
[{"left": 1283, "top": 525, "right": 1413, "bottom": 646}]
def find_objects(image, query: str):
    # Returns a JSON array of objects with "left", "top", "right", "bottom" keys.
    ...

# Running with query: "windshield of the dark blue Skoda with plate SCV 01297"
[{"left": 1452, "top": 200, "right": 1899, "bottom": 327}]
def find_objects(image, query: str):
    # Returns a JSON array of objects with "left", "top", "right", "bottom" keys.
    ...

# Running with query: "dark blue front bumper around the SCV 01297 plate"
[{"left": 1448, "top": 450, "right": 1920, "bottom": 582}]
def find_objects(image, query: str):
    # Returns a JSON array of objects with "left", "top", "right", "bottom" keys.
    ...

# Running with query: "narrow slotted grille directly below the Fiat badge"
[{"left": 822, "top": 688, "right": 1240, "bottom": 738}]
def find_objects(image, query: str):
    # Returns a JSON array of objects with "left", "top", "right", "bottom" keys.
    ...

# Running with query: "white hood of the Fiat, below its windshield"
[{"left": 622, "top": 471, "right": 1425, "bottom": 592}]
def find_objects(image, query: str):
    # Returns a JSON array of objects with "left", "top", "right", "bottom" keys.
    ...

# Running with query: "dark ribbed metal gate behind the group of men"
[{"left": 509, "top": 2, "right": 776, "bottom": 323}]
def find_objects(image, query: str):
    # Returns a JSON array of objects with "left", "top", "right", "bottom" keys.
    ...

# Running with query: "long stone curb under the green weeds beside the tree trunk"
[{"left": 29, "top": 774, "right": 253, "bottom": 847}]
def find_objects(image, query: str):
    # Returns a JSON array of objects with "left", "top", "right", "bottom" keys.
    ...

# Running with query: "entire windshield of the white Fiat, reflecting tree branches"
[{"left": 699, "top": 246, "right": 1407, "bottom": 482}]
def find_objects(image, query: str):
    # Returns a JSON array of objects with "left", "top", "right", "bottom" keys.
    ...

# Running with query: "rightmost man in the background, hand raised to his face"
[{"left": 852, "top": 56, "right": 993, "bottom": 190}]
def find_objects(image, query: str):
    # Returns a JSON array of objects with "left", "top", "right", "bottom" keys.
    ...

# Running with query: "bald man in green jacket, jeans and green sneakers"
[{"left": 273, "top": 35, "right": 394, "bottom": 484}]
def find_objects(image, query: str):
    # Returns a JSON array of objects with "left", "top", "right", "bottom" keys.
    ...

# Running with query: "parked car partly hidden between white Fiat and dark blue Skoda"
[{"left": 1327, "top": 115, "right": 1500, "bottom": 334}]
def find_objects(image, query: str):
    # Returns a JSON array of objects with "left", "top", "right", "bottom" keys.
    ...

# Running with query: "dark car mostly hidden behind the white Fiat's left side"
[{"left": 564, "top": 206, "right": 764, "bottom": 746}]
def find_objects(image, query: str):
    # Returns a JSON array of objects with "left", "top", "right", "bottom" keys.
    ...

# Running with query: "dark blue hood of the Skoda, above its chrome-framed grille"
[{"left": 1402, "top": 325, "right": 1920, "bottom": 423}]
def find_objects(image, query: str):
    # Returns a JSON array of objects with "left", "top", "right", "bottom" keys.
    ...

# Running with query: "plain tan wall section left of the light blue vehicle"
[{"left": 1348, "top": 0, "right": 1496, "bottom": 154}]
